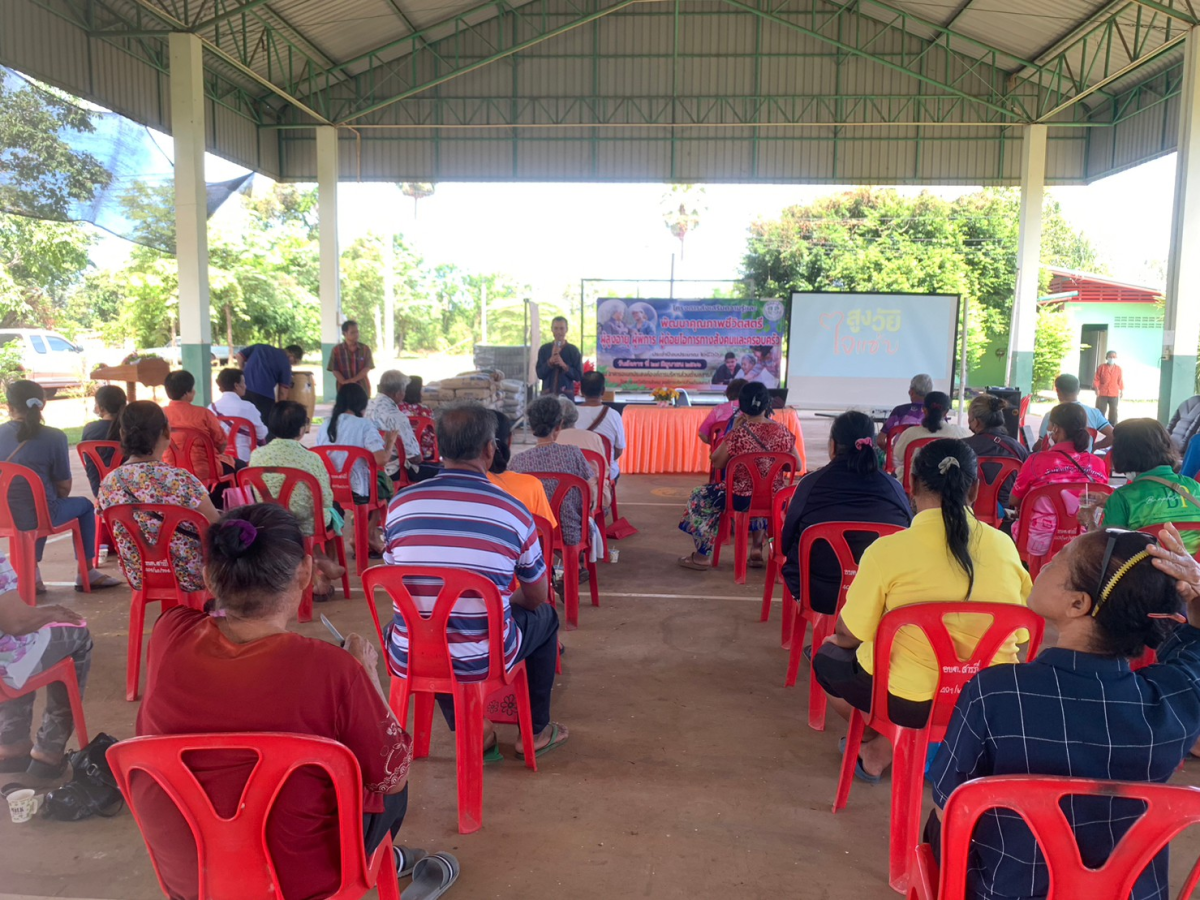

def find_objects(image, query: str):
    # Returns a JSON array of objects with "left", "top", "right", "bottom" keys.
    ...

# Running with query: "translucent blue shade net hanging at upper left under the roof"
[{"left": 0, "top": 66, "right": 254, "bottom": 256}]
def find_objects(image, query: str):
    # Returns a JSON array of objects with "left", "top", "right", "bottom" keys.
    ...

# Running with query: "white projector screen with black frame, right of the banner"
[{"left": 787, "top": 293, "right": 959, "bottom": 409}]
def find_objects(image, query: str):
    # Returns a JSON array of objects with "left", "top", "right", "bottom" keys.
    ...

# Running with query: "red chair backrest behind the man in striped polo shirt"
[{"left": 362, "top": 564, "right": 511, "bottom": 679}]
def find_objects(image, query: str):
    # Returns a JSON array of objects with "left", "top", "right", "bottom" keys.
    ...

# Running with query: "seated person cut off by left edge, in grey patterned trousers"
[{"left": 0, "top": 554, "right": 91, "bottom": 779}]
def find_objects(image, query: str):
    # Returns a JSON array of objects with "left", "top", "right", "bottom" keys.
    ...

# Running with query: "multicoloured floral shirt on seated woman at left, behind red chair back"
[{"left": 96, "top": 462, "right": 209, "bottom": 592}]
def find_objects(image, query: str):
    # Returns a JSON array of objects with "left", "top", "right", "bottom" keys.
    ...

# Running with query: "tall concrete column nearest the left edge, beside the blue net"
[{"left": 169, "top": 34, "right": 212, "bottom": 406}]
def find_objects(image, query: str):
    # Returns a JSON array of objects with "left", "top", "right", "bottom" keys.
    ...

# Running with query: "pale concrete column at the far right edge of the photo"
[{"left": 1156, "top": 28, "right": 1200, "bottom": 422}]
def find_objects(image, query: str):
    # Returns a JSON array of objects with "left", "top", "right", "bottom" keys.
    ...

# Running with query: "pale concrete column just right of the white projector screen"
[{"left": 1008, "top": 125, "right": 1046, "bottom": 394}]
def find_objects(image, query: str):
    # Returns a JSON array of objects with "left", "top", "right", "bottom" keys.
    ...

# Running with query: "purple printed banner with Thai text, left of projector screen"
[{"left": 596, "top": 298, "right": 787, "bottom": 392}]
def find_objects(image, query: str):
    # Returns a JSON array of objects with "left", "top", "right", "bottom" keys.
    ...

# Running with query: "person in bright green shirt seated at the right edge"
[{"left": 1104, "top": 419, "right": 1200, "bottom": 554}]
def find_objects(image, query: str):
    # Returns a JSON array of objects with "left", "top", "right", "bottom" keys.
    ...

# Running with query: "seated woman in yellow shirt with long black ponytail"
[{"left": 814, "top": 439, "right": 1033, "bottom": 784}]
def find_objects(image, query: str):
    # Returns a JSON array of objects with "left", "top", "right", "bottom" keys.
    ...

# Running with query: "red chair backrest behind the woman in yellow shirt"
[{"left": 871, "top": 601, "right": 1045, "bottom": 742}]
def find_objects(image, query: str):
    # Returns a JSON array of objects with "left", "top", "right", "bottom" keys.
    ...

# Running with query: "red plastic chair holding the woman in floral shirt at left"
[{"left": 101, "top": 503, "right": 209, "bottom": 701}]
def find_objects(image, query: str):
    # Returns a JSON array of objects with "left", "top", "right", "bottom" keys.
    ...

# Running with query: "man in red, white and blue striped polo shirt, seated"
[{"left": 383, "top": 403, "right": 568, "bottom": 756}]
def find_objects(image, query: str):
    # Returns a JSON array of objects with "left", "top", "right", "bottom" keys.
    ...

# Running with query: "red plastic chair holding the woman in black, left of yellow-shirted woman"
[{"left": 784, "top": 522, "right": 904, "bottom": 731}]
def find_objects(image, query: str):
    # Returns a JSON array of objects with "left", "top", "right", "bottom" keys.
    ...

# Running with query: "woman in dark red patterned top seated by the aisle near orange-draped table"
[{"left": 679, "top": 382, "right": 802, "bottom": 571}]
